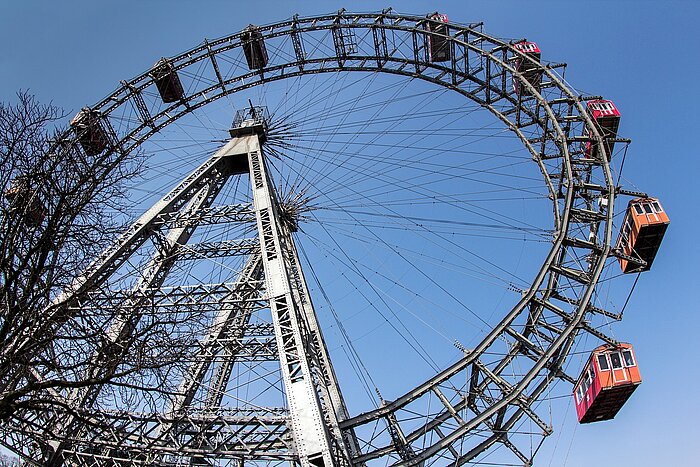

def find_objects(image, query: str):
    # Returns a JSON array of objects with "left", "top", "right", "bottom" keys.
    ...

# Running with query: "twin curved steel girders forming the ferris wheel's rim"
[{"left": 45, "top": 11, "right": 616, "bottom": 466}]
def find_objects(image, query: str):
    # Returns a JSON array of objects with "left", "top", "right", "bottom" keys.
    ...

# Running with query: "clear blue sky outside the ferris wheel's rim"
[{"left": 0, "top": 0, "right": 700, "bottom": 467}]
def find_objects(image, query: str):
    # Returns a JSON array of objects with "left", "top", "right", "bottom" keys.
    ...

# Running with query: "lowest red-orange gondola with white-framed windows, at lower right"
[{"left": 574, "top": 344, "right": 642, "bottom": 423}]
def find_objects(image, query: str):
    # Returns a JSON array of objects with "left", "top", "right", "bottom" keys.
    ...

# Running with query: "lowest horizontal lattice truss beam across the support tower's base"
[{"left": 56, "top": 408, "right": 294, "bottom": 465}]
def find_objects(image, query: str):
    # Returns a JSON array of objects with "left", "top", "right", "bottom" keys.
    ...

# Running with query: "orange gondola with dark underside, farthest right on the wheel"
[{"left": 617, "top": 198, "right": 670, "bottom": 272}]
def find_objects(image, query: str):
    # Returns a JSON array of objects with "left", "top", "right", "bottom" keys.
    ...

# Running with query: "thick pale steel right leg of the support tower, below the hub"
[{"left": 245, "top": 135, "right": 356, "bottom": 466}]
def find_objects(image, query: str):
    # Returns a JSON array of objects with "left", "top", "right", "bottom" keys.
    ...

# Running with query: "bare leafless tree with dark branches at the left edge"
[{"left": 0, "top": 92, "right": 208, "bottom": 464}]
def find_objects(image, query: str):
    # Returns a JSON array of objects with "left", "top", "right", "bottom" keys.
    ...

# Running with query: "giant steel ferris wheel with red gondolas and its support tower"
[{"left": 1, "top": 10, "right": 668, "bottom": 466}]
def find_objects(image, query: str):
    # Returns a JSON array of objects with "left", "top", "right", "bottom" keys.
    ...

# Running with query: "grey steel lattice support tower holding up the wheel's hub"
[{"left": 37, "top": 106, "right": 359, "bottom": 466}]
